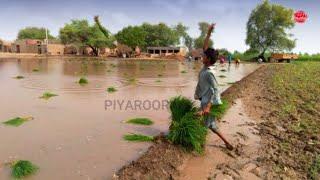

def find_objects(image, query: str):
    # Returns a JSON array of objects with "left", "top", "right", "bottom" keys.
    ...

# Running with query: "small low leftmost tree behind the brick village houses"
[{"left": 17, "top": 27, "right": 55, "bottom": 40}]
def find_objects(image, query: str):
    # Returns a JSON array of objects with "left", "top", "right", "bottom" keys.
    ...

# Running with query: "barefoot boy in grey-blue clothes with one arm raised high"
[{"left": 195, "top": 24, "right": 233, "bottom": 150}]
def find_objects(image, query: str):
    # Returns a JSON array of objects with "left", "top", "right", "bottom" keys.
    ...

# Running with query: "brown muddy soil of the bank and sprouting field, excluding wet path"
[{"left": 117, "top": 63, "right": 320, "bottom": 179}]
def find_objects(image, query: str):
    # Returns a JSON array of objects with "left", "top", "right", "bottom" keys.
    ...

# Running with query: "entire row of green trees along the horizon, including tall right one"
[{"left": 17, "top": 0, "right": 302, "bottom": 58}]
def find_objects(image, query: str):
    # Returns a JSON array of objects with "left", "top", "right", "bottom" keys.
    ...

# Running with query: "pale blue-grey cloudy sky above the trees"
[{"left": 0, "top": 0, "right": 320, "bottom": 53}]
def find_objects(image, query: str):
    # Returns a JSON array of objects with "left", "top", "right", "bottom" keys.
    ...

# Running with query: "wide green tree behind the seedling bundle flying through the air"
[{"left": 60, "top": 20, "right": 110, "bottom": 56}]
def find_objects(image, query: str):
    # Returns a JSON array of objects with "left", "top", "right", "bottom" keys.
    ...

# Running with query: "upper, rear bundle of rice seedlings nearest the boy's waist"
[{"left": 169, "top": 96, "right": 197, "bottom": 121}]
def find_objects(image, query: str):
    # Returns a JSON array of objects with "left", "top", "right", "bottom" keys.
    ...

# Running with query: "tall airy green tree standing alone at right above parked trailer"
[{"left": 246, "top": 0, "right": 295, "bottom": 59}]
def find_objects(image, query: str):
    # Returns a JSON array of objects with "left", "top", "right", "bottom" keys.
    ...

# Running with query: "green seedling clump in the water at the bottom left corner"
[{"left": 11, "top": 160, "right": 39, "bottom": 179}]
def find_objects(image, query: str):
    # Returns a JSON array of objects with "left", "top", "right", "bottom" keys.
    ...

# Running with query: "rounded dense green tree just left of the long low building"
[{"left": 115, "top": 26, "right": 147, "bottom": 49}]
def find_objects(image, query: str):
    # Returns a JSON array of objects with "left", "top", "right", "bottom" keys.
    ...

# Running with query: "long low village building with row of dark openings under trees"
[{"left": 147, "top": 47, "right": 187, "bottom": 57}]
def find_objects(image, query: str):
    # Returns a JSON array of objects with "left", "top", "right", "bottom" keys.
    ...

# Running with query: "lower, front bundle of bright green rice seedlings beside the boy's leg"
[{"left": 168, "top": 112, "right": 207, "bottom": 154}]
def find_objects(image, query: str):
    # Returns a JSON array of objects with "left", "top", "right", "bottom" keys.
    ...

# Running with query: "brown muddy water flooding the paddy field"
[{"left": 0, "top": 59, "right": 258, "bottom": 179}]
